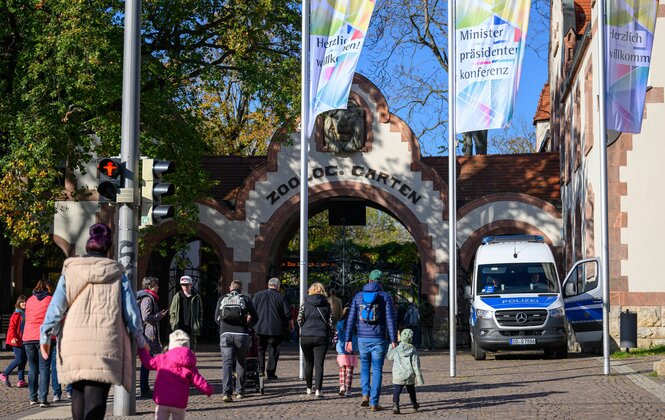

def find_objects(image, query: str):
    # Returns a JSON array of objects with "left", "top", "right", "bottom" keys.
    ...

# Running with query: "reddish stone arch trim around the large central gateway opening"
[{"left": 250, "top": 181, "right": 447, "bottom": 294}]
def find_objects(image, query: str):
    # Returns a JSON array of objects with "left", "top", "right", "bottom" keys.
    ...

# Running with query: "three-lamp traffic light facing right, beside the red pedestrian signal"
[{"left": 140, "top": 159, "right": 175, "bottom": 226}]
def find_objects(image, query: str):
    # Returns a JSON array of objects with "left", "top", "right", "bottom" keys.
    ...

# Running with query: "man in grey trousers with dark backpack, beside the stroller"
[{"left": 215, "top": 280, "right": 259, "bottom": 402}]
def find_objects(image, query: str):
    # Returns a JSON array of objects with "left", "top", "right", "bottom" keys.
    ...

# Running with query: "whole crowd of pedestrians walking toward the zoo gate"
[{"left": 0, "top": 224, "right": 433, "bottom": 419}]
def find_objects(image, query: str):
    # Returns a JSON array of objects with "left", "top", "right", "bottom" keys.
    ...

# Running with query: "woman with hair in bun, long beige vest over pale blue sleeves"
[{"left": 40, "top": 223, "right": 147, "bottom": 420}]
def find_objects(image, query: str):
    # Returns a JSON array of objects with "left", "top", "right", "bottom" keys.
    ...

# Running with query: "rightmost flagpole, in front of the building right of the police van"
[{"left": 597, "top": 0, "right": 610, "bottom": 375}]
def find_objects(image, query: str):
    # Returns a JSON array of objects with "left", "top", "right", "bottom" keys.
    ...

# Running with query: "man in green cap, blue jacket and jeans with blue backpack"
[{"left": 345, "top": 270, "right": 397, "bottom": 411}]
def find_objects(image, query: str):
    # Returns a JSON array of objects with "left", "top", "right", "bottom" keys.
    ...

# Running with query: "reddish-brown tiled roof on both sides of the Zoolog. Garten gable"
[{"left": 202, "top": 153, "right": 560, "bottom": 207}]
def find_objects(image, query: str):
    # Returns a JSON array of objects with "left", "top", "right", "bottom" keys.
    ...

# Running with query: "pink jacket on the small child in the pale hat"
[{"left": 139, "top": 347, "right": 213, "bottom": 408}]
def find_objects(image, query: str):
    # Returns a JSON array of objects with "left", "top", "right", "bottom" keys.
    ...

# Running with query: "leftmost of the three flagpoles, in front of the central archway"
[{"left": 299, "top": 0, "right": 310, "bottom": 379}]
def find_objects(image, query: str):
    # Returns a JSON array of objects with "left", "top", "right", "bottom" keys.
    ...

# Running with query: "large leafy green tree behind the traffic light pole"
[{"left": 0, "top": 0, "right": 299, "bottom": 245}]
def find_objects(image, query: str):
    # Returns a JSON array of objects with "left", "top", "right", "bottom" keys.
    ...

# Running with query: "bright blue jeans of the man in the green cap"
[{"left": 358, "top": 339, "right": 388, "bottom": 406}]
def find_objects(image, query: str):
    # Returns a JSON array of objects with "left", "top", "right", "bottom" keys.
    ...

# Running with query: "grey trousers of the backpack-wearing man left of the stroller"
[{"left": 219, "top": 333, "right": 250, "bottom": 395}]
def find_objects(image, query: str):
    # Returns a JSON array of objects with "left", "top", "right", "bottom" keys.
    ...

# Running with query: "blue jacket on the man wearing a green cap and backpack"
[{"left": 344, "top": 281, "right": 397, "bottom": 343}]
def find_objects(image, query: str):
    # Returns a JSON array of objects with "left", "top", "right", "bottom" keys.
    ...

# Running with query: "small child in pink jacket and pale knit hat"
[{"left": 139, "top": 330, "right": 212, "bottom": 420}]
